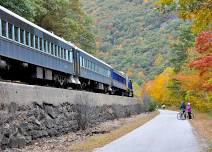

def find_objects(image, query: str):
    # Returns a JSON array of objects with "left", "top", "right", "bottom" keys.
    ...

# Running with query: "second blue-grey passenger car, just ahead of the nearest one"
[{"left": 77, "top": 48, "right": 112, "bottom": 92}]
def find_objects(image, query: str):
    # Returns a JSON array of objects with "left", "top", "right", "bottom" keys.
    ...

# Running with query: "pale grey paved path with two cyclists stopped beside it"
[{"left": 95, "top": 110, "right": 200, "bottom": 152}]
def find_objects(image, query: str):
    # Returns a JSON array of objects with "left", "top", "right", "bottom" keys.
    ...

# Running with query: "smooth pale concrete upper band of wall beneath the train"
[{"left": 0, "top": 82, "right": 141, "bottom": 106}]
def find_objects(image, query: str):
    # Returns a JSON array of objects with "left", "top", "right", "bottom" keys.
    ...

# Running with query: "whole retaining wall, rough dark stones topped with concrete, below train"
[{"left": 0, "top": 84, "right": 144, "bottom": 149}]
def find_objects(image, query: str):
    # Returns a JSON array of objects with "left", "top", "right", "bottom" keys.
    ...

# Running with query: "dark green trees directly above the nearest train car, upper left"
[{"left": 0, "top": 0, "right": 96, "bottom": 53}]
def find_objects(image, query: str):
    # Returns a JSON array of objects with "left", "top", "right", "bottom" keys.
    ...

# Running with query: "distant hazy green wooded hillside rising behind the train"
[{"left": 81, "top": 0, "right": 186, "bottom": 85}]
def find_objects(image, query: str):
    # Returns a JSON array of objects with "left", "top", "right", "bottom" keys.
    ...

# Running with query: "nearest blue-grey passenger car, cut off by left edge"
[{"left": 0, "top": 6, "right": 76, "bottom": 86}]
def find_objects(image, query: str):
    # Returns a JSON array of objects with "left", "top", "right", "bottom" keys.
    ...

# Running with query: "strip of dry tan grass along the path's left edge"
[{"left": 68, "top": 112, "right": 159, "bottom": 152}]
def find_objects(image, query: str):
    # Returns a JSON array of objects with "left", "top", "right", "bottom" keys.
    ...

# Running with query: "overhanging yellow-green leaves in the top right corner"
[{"left": 156, "top": 0, "right": 212, "bottom": 34}]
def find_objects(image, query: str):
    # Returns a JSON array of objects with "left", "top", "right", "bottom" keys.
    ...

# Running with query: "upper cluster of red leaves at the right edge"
[{"left": 195, "top": 30, "right": 212, "bottom": 53}]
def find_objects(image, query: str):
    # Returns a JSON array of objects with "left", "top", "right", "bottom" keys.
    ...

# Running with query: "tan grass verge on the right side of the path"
[{"left": 190, "top": 112, "right": 212, "bottom": 152}]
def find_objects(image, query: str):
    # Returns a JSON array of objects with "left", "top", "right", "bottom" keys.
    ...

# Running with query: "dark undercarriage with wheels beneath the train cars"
[{"left": 0, "top": 56, "right": 130, "bottom": 96}]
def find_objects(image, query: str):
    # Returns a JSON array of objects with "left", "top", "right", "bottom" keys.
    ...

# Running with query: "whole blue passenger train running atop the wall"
[{"left": 0, "top": 6, "right": 133, "bottom": 97}]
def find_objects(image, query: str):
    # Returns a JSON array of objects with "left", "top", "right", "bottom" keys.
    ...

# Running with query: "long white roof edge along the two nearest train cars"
[{"left": 0, "top": 5, "right": 112, "bottom": 68}]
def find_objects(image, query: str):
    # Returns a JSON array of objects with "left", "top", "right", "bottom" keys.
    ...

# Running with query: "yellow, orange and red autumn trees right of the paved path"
[{"left": 142, "top": 0, "right": 212, "bottom": 112}]
